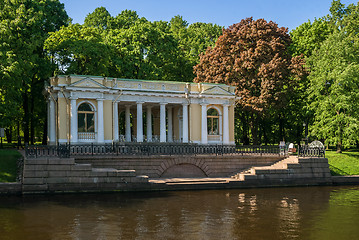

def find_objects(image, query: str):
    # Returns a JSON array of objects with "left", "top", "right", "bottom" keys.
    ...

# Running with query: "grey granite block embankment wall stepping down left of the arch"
[{"left": 22, "top": 157, "right": 148, "bottom": 194}]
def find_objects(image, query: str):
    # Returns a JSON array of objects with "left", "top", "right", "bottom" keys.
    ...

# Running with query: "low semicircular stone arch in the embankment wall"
[{"left": 159, "top": 156, "right": 209, "bottom": 177}]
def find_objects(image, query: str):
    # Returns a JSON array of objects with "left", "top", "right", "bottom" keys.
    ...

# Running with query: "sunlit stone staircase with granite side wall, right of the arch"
[{"left": 231, "top": 156, "right": 331, "bottom": 182}]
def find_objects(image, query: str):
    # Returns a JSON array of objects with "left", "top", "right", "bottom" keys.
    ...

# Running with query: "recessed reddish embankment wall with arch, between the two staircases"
[{"left": 75, "top": 154, "right": 284, "bottom": 178}]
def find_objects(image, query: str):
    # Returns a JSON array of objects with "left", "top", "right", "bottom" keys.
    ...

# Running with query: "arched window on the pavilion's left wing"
[{"left": 77, "top": 103, "right": 95, "bottom": 132}]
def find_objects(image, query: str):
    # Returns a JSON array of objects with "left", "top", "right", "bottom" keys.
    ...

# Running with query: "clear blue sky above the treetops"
[{"left": 60, "top": 0, "right": 357, "bottom": 31}]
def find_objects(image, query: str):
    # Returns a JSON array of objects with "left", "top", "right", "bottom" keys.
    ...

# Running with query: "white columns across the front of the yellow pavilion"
[{"left": 48, "top": 98, "right": 230, "bottom": 144}]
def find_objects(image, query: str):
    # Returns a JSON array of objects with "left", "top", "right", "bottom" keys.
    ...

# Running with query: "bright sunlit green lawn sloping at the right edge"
[{"left": 325, "top": 150, "right": 359, "bottom": 176}]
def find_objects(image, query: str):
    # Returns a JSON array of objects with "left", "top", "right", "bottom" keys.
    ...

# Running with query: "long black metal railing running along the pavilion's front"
[{"left": 25, "top": 143, "right": 288, "bottom": 158}]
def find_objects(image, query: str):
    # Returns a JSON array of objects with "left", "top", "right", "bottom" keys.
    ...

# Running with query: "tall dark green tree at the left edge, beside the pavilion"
[{"left": 0, "top": 0, "right": 68, "bottom": 142}]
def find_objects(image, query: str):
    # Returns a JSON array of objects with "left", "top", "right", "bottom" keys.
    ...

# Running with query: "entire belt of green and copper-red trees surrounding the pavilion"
[{"left": 0, "top": 0, "right": 359, "bottom": 147}]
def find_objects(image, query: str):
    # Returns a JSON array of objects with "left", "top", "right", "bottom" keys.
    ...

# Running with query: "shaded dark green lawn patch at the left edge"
[{"left": 0, "top": 149, "right": 21, "bottom": 182}]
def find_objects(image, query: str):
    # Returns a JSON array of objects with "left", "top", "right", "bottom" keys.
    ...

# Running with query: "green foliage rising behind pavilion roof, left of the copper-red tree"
[{"left": 45, "top": 7, "right": 221, "bottom": 81}]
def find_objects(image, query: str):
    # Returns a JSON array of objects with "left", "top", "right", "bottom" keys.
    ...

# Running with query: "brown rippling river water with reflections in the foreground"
[{"left": 0, "top": 186, "right": 359, "bottom": 240}]
